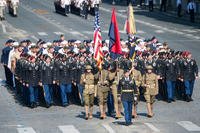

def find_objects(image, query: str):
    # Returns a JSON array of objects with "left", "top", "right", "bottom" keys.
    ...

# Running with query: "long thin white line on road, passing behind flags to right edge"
[{"left": 100, "top": 7, "right": 199, "bottom": 39}]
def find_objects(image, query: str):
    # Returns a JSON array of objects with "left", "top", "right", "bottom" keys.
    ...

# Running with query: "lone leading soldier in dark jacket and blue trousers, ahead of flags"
[{"left": 118, "top": 70, "right": 137, "bottom": 126}]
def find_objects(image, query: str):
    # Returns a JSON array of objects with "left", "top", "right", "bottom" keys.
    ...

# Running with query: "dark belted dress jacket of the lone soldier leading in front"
[{"left": 118, "top": 77, "right": 136, "bottom": 101}]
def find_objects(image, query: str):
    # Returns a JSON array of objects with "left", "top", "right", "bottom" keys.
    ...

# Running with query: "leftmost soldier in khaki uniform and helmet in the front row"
[{"left": 80, "top": 65, "right": 95, "bottom": 120}]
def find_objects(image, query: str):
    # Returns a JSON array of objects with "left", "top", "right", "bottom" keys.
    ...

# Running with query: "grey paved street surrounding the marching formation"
[{"left": 0, "top": 0, "right": 200, "bottom": 133}]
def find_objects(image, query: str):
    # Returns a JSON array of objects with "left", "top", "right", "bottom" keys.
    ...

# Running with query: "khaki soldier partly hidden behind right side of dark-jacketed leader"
[{"left": 130, "top": 62, "right": 142, "bottom": 118}]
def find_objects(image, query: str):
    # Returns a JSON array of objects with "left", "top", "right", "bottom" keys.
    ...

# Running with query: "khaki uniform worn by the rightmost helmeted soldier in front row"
[{"left": 142, "top": 73, "right": 158, "bottom": 104}]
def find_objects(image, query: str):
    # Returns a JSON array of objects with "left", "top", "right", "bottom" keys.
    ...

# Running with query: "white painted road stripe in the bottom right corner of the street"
[{"left": 177, "top": 121, "right": 200, "bottom": 132}]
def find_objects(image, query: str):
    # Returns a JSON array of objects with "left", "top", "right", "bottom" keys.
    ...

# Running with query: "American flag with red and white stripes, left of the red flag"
[{"left": 94, "top": 11, "right": 103, "bottom": 69}]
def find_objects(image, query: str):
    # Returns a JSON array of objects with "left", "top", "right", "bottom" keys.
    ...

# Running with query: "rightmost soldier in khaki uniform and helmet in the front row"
[{"left": 142, "top": 66, "right": 158, "bottom": 118}]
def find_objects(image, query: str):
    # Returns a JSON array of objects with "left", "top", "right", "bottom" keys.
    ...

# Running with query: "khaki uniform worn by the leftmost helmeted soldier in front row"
[{"left": 80, "top": 73, "right": 95, "bottom": 107}]
